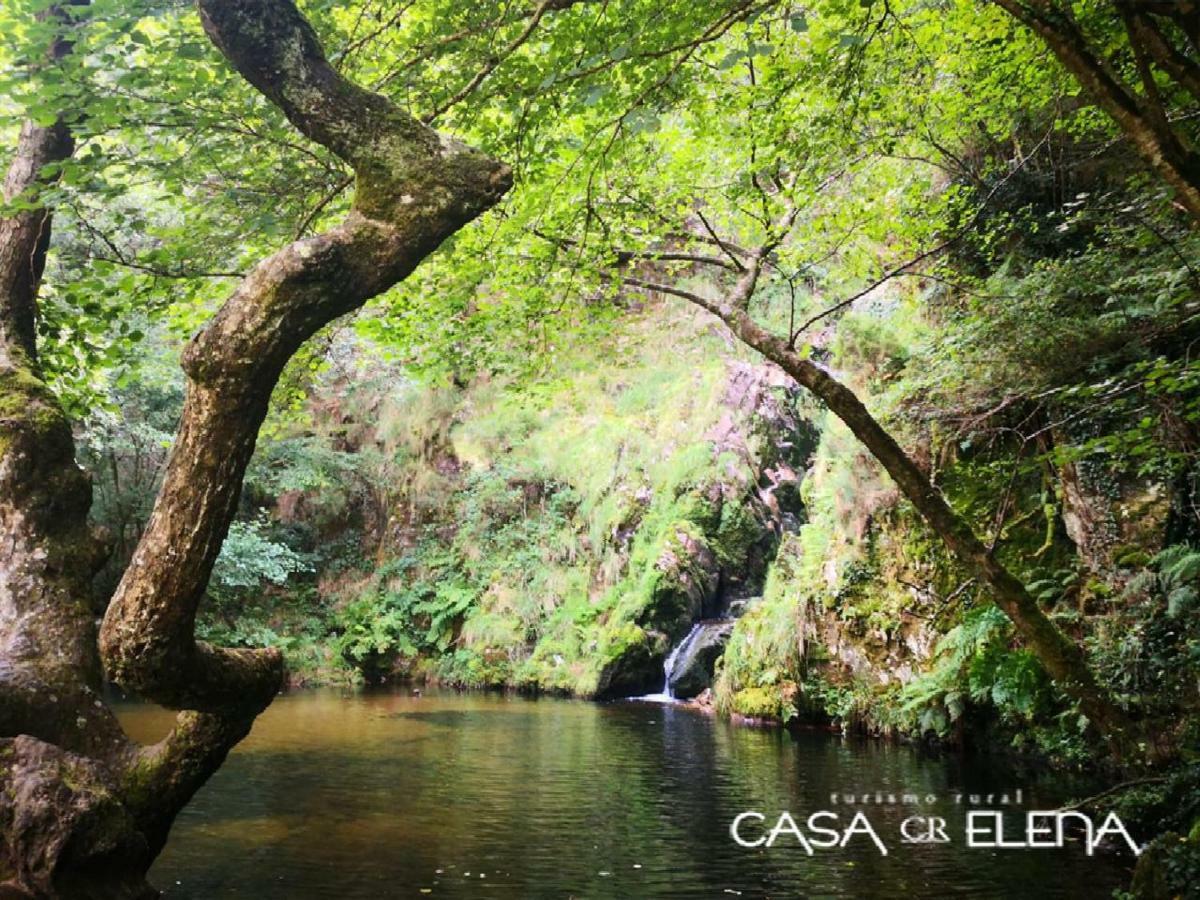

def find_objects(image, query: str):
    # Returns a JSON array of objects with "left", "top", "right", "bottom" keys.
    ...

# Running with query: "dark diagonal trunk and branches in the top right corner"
[{"left": 991, "top": 0, "right": 1200, "bottom": 220}]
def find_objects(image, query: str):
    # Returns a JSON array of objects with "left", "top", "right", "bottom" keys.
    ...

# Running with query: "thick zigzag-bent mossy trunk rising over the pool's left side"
[{"left": 101, "top": 0, "right": 511, "bottom": 720}]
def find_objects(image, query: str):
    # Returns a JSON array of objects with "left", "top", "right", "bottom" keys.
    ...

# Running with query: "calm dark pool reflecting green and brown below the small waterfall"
[{"left": 114, "top": 691, "right": 1138, "bottom": 900}]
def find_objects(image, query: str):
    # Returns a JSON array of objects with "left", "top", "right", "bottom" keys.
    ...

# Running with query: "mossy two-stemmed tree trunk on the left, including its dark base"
[{"left": 0, "top": 0, "right": 511, "bottom": 898}]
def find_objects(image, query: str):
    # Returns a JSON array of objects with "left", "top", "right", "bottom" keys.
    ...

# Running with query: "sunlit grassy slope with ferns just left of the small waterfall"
[{"left": 300, "top": 304, "right": 790, "bottom": 695}]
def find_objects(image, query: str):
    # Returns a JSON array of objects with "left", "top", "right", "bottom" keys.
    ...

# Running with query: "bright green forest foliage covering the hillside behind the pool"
[{"left": 0, "top": 0, "right": 1200, "bottom": 888}]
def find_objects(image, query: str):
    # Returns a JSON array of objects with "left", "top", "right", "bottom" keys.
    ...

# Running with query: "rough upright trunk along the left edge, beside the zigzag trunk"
[{"left": 0, "top": 7, "right": 156, "bottom": 896}]
